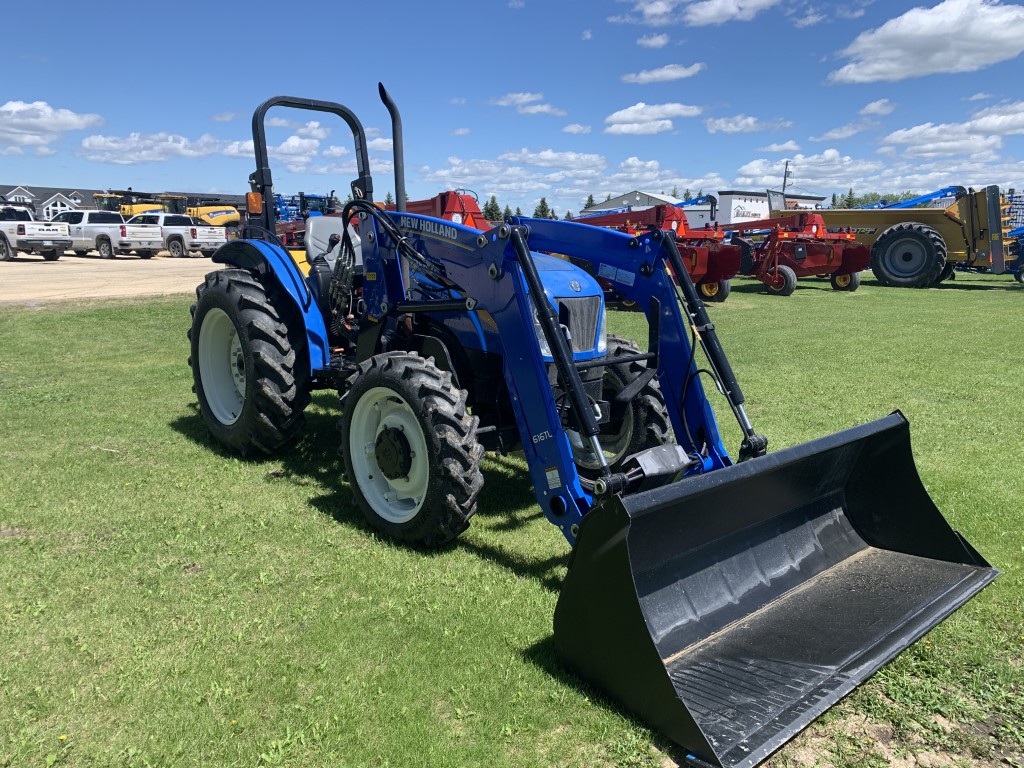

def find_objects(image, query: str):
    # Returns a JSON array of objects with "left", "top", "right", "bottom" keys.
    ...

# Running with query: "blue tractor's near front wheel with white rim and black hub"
[{"left": 341, "top": 352, "right": 483, "bottom": 547}]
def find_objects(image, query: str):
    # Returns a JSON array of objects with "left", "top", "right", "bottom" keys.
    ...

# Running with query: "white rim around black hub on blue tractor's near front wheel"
[{"left": 348, "top": 387, "right": 430, "bottom": 523}]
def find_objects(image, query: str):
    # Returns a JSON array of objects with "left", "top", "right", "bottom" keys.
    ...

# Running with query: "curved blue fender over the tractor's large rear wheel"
[{"left": 211, "top": 240, "right": 331, "bottom": 373}]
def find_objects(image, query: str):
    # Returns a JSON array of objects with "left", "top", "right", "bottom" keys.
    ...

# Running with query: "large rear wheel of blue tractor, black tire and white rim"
[{"left": 188, "top": 269, "right": 309, "bottom": 456}]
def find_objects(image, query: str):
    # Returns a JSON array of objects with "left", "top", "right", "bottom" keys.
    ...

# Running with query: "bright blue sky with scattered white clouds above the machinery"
[{"left": 0, "top": 0, "right": 1024, "bottom": 215}]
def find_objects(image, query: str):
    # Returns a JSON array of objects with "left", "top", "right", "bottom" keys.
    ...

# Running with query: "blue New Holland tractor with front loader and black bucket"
[{"left": 189, "top": 86, "right": 996, "bottom": 768}]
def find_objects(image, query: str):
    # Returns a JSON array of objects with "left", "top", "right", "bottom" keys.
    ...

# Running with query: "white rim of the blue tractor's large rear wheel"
[{"left": 199, "top": 307, "right": 246, "bottom": 426}]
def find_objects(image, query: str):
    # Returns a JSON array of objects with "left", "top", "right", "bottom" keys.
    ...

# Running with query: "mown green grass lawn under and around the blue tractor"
[{"left": 0, "top": 275, "right": 1024, "bottom": 767}]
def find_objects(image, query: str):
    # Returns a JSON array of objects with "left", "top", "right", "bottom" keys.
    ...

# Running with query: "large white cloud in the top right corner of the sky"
[{"left": 828, "top": 0, "right": 1024, "bottom": 83}]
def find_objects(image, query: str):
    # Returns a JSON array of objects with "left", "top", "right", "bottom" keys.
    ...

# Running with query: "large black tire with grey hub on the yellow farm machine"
[{"left": 871, "top": 222, "right": 946, "bottom": 288}]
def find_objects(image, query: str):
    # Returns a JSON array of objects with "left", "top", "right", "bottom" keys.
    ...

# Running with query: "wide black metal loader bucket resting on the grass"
[{"left": 554, "top": 413, "right": 997, "bottom": 768}]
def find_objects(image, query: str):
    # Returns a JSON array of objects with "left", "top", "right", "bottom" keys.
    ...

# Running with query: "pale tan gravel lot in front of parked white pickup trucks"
[{"left": 0, "top": 253, "right": 220, "bottom": 305}]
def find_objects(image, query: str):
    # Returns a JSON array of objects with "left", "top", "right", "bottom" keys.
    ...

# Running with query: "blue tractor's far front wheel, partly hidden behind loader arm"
[{"left": 566, "top": 334, "right": 670, "bottom": 480}]
